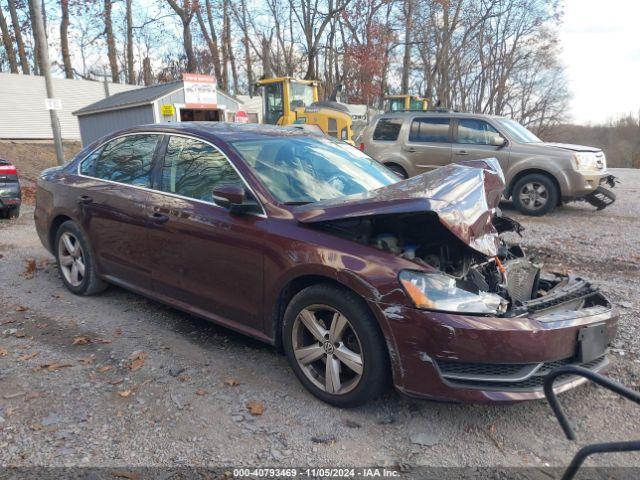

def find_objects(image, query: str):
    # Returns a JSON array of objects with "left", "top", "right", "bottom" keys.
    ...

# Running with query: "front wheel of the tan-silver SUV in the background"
[{"left": 511, "top": 173, "right": 560, "bottom": 217}]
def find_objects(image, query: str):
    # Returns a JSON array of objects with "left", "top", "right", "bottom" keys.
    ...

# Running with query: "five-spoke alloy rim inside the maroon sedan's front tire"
[{"left": 292, "top": 305, "right": 364, "bottom": 395}]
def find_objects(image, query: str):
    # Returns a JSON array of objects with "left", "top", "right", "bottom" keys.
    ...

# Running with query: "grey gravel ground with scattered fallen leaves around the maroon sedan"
[{"left": 0, "top": 170, "right": 640, "bottom": 471}]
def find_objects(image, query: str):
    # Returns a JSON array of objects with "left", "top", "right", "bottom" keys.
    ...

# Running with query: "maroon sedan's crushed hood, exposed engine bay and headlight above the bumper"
[{"left": 296, "top": 159, "right": 610, "bottom": 317}]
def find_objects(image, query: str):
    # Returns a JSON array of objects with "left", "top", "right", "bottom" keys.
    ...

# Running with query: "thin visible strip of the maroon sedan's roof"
[{"left": 103, "top": 122, "right": 310, "bottom": 142}]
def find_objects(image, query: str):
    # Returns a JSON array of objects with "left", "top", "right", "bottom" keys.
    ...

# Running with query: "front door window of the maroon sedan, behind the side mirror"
[{"left": 160, "top": 137, "right": 244, "bottom": 203}]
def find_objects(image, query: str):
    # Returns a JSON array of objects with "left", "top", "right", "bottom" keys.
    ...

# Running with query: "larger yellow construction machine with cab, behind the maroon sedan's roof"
[{"left": 257, "top": 77, "right": 353, "bottom": 144}]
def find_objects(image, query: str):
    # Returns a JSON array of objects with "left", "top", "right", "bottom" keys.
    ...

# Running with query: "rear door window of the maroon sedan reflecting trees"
[{"left": 92, "top": 134, "right": 160, "bottom": 187}]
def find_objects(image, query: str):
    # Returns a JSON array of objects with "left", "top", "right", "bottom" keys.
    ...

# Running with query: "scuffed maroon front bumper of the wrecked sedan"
[{"left": 378, "top": 282, "right": 617, "bottom": 402}]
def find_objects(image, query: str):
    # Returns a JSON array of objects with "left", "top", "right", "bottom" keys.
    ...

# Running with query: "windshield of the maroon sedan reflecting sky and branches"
[{"left": 231, "top": 136, "right": 398, "bottom": 205}]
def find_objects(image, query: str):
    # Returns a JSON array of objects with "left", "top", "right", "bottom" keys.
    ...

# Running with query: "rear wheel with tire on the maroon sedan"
[{"left": 54, "top": 220, "right": 107, "bottom": 295}]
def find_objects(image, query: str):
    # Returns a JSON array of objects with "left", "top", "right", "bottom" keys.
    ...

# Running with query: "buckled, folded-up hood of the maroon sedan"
[{"left": 293, "top": 158, "right": 504, "bottom": 257}]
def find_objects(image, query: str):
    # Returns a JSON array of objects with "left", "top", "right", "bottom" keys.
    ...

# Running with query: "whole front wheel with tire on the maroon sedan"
[{"left": 282, "top": 284, "right": 390, "bottom": 407}]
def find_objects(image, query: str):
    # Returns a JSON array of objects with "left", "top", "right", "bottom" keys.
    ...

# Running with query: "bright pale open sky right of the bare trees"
[{"left": 560, "top": 0, "right": 640, "bottom": 124}]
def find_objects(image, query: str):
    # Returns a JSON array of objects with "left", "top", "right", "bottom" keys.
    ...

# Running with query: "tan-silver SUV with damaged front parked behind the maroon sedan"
[{"left": 359, "top": 111, "right": 615, "bottom": 215}]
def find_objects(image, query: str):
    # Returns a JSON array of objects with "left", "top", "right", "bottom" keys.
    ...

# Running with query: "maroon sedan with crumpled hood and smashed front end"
[{"left": 35, "top": 124, "right": 617, "bottom": 406}]
